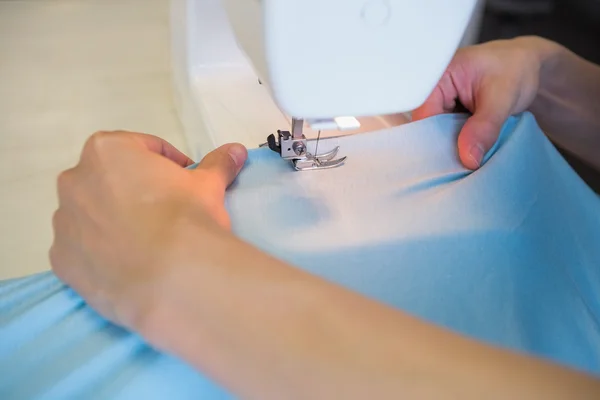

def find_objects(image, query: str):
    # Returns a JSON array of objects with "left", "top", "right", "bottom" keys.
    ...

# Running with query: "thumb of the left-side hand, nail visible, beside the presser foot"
[{"left": 196, "top": 143, "right": 248, "bottom": 193}]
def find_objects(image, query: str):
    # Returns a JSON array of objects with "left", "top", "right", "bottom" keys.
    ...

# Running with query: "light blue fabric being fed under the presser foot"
[{"left": 0, "top": 114, "right": 600, "bottom": 399}]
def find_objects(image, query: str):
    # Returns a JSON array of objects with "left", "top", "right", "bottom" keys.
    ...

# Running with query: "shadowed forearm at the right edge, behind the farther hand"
[{"left": 531, "top": 36, "right": 600, "bottom": 170}]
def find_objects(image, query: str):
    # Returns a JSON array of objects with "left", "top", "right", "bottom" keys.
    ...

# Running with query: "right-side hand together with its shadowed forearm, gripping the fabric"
[{"left": 413, "top": 37, "right": 600, "bottom": 170}]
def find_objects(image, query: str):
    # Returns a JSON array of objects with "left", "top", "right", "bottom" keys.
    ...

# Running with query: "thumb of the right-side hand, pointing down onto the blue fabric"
[{"left": 458, "top": 83, "right": 512, "bottom": 170}]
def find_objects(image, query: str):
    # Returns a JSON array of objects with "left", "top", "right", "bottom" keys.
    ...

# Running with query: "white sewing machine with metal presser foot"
[{"left": 171, "top": 0, "right": 483, "bottom": 170}]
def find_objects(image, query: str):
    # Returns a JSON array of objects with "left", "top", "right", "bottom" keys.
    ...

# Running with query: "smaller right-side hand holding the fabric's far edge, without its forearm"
[{"left": 413, "top": 37, "right": 552, "bottom": 169}]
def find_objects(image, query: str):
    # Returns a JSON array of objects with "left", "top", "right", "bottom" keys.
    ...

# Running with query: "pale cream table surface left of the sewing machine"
[{"left": 0, "top": 0, "right": 186, "bottom": 279}]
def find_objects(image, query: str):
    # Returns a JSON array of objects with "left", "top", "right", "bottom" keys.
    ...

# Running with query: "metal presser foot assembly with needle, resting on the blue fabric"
[{"left": 265, "top": 118, "right": 346, "bottom": 171}]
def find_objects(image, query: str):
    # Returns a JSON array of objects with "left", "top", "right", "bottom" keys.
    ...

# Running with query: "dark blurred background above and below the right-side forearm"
[{"left": 479, "top": 0, "right": 600, "bottom": 193}]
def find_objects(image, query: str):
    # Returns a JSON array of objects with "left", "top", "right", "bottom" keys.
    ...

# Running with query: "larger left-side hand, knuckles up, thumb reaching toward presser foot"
[{"left": 50, "top": 132, "right": 247, "bottom": 329}]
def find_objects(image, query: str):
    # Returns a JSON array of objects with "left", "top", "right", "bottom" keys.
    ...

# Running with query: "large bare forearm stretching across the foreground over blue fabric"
[{"left": 135, "top": 230, "right": 600, "bottom": 399}]
